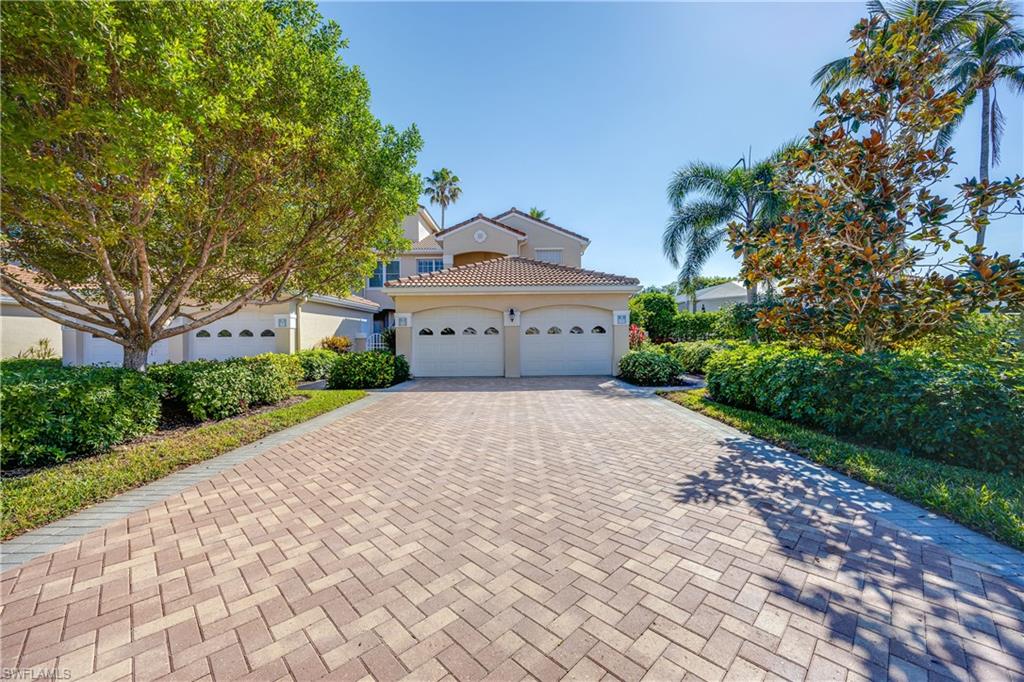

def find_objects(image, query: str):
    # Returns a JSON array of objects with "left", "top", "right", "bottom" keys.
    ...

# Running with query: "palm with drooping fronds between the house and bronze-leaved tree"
[{"left": 662, "top": 148, "right": 793, "bottom": 303}]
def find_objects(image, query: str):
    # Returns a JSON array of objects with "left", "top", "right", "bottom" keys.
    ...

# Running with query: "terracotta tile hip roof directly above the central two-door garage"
[{"left": 384, "top": 256, "right": 640, "bottom": 289}]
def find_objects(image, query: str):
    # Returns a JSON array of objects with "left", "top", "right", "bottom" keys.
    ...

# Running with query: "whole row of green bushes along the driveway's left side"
[{"left": 0, "top": 349, "right": 409, "bottom": 468}]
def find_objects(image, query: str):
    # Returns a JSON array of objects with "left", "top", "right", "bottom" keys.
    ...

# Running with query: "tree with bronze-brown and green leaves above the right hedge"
[{"left": 730, "top": 18, "right": 1024, "bottom": 351}]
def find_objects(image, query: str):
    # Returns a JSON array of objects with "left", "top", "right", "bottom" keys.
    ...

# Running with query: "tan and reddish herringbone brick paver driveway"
[{"left": 0, "top": 379, "right": 1024, "bottom": 680}]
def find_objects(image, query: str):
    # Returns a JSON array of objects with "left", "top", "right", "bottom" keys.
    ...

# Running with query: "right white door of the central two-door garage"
[{"left": 519, "top": 305, "right": 612, "bottom": 377}]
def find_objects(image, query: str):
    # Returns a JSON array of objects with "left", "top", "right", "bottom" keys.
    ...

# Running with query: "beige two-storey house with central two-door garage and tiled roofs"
[{"left": 383, "top": 209, "right": 639, "bottom": 377}]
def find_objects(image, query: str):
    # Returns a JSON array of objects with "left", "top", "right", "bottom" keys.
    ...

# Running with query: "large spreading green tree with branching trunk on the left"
[{"left": 0, "top": 0, "right": 420, "bottom": 369}]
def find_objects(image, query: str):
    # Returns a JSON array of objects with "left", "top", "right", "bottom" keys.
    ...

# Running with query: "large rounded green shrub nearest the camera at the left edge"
[{"left": 0, "top": 360, "right": 161, "bottom": 467}]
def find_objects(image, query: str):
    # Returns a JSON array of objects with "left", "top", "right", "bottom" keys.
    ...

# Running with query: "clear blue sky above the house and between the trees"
[{"left": 321, "top": 2, "right": 1024, "bottom": 285}]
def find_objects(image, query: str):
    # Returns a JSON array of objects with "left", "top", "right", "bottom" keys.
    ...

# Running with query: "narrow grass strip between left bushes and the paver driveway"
[{"left": 0, "top": 391, "right": 366, "bottom": 540}]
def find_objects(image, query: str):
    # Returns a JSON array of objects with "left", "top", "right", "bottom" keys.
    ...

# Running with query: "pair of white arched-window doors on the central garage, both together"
[{"left": 413, "top": 306, "right": 612, "bottom": 377}]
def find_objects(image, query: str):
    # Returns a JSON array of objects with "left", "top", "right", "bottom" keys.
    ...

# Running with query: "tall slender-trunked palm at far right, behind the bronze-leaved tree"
[{"left": 942, "top": 9, "right": 1024, "bottom": 246}]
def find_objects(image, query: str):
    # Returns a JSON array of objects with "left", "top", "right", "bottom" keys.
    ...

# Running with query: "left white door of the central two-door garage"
[{"left": 412, "top": 308, "right": 505, "bottom": 377}]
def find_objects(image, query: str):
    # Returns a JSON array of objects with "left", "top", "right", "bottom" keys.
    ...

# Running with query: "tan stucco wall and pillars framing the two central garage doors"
[{"left": 395, "top": 292, "right": 630, "bottom": 377}]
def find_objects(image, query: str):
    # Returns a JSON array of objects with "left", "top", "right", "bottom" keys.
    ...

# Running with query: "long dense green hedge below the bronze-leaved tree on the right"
[{"left": 707, "top": 344, "right": 1024, "bottom": 474}]
